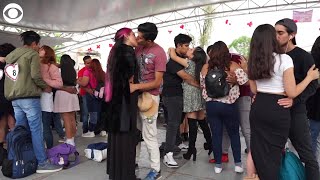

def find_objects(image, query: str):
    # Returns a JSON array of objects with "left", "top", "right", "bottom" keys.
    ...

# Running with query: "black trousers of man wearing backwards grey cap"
[{"left": 289, "top": 108, "right": 320, "bottom": 180}]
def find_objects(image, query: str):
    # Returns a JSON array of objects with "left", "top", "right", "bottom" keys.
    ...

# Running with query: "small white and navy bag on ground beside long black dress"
[{"left": 84, "top": 142, "right": 108, "bottom": 162}]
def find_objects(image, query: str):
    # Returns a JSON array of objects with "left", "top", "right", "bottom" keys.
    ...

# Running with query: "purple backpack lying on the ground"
[{"left": 47, "top": 143, "right": 79, "bottom": 169}]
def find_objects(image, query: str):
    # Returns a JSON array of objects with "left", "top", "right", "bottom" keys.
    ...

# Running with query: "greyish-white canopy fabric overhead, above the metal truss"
[{"left": 0, "top": 0, "right": 227, "bottom": 32}]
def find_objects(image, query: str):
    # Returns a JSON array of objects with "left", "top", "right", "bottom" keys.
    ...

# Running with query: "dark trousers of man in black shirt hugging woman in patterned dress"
[{"left": 162, "top": 96, "right": 183, "bottom": 153}]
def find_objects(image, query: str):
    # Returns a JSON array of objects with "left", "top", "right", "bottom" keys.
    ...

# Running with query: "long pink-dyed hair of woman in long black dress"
[{"left": 106, "top": 28, "right": 132, "bottom": 82}]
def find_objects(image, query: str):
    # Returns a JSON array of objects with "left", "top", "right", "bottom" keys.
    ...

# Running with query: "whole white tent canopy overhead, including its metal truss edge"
[{"left": 0, "top": 0, "right": 320, "bottom": 48}]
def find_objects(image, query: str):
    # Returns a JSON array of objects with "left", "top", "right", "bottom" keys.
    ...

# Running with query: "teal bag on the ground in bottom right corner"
[{"left": 279, "top": 149, "right": 306, "bottom": 180}]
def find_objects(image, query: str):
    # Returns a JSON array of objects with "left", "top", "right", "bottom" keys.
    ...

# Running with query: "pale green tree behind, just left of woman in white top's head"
[{"left": 229, "top": 36, "right": 251, "bottom": 57}]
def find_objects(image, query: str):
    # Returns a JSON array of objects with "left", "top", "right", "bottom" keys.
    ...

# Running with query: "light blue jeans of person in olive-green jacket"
[{"left": 12, "top": 98, "right": 47, "bottom": 165}]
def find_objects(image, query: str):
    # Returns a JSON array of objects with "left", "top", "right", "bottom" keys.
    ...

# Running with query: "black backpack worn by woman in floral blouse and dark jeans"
[{"left": 205, "top": 67, "right": 230, "bottom": 98}]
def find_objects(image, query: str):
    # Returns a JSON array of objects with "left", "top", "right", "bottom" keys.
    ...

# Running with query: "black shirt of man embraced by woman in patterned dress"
[{"left": 162, "top": 59, "right": 184, "bottom": 97}]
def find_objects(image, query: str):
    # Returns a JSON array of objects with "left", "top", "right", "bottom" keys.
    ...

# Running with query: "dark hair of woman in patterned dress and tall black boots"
[{"left": 192, "top": 46, "right": 207, "bottom": 82}]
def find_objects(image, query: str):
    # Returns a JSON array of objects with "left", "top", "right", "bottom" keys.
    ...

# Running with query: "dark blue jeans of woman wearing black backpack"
[{"left": 207, "top": 101, "right": 241, "bottom": 166}]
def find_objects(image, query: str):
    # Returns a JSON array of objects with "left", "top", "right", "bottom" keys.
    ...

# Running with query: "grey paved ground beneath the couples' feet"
[{"left": 0, "top": 114, "right": 246, "bottom": 180}]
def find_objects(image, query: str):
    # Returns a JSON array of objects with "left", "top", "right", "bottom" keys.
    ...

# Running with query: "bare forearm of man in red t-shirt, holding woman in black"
[{"left": 130, "top": 72, "right": 163, "bottom": 92}]
